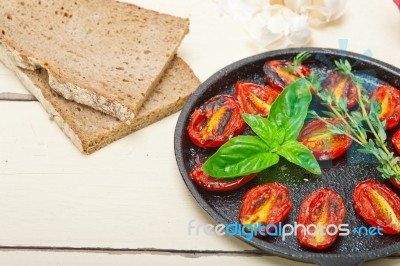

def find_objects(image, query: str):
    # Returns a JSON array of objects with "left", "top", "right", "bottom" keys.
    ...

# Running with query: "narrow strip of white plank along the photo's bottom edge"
[{"left": 0, "top": 250, "right": 400, "bottom": 266}]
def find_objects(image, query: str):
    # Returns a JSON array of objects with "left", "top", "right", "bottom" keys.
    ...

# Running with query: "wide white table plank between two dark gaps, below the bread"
[{"left": 0, "top": 102, "right": 252, "bottom": 250}]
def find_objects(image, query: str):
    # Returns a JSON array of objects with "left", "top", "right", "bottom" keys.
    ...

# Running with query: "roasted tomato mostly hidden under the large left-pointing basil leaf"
[{"left": 190, "top": 165, "right": 256, "bottom": 191}]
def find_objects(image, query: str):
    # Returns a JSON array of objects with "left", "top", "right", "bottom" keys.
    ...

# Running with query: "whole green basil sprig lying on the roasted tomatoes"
[{"left": 203, "top": 78, "right": 321, "bottom": 178}]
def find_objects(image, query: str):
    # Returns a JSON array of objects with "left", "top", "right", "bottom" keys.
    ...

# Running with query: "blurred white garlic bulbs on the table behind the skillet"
[{"left": 216, "top": 0, "right": 346, "bottom": 49}]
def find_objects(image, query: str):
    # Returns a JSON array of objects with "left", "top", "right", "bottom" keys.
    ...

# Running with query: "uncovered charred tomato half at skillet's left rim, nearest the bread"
[{"left": 188, "top": 95, "right": 246, "bottom": 148}]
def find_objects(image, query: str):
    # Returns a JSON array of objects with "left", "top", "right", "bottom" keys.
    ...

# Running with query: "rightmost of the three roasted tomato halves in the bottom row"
[{"left": 353, "top": 179, "right": 400, "bottom": 234}]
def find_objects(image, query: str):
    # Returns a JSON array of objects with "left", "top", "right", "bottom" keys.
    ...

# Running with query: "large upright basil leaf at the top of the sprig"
[{"left": 268, "top": 78, "right": 312, "bottom": 141}]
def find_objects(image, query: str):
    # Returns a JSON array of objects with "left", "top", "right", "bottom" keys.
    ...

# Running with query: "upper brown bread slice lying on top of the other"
[{"left": 0, "top": 0, "right": 189, "bottom": 121}]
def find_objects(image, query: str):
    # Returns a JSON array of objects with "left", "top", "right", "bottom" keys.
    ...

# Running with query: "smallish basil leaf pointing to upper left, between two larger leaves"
[{"left": 242, "top": 114, "right": 285, "bottom": 150}]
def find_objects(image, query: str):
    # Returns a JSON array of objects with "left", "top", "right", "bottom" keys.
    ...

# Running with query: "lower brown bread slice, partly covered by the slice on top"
[{"left": 0, "top": 50, "right": 200, "bottom": 154}]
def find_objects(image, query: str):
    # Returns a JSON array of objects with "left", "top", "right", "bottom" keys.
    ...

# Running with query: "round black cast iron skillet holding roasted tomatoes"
[{"left": 175, "top": 48, "right": 400, "bottom": 265}]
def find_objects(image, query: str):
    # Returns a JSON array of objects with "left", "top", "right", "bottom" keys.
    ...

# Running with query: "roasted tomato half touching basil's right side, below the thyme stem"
[{"left": 297, "top": 118, "right": 353, "bottom": 161}]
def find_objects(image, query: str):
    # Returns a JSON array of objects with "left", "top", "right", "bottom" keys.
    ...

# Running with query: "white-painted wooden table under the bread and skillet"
[{"left": 0, "top": 0, "right": 400, "bottom": 265}]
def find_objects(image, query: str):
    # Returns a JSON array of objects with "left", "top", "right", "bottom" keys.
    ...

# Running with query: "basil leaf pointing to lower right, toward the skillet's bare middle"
[{"left": 277, "top": 140, "right": 322, "bottom": 175}]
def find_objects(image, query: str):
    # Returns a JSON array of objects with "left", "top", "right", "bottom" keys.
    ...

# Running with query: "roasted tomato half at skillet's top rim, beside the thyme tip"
[{"left": 263, "top": 60, "right": 311, "bottom": 91}]
